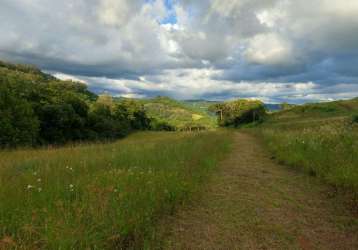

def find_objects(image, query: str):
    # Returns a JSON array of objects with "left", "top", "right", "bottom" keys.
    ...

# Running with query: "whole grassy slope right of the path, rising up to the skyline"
[{"left": 260, "top": 99, "right": 358, "bottom": 203}]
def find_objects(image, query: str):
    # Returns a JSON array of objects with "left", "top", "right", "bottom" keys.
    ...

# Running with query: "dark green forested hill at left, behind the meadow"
[{"left": 0, "top": 59, "right": 150, "bottom": 147}]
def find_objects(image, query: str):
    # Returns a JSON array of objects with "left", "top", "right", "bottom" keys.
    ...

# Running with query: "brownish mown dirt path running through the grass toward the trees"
[{"left": 165, "top": 133, "right": 358, "bottom": 250}]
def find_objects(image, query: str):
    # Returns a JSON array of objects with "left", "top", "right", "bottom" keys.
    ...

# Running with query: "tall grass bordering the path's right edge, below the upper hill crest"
[{"left": 260, "top": 119, "right": 358, "bottom": 202}]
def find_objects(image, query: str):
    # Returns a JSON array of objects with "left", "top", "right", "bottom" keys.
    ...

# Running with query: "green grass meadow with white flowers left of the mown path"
[{"left": 0, "top": 131, "right": 231, "bottom": 249}]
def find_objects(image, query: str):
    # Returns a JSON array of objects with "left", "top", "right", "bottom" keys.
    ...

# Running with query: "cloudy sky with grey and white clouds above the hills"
[{"left": 0, "top": 0, "right": 358, "bottom": 103}]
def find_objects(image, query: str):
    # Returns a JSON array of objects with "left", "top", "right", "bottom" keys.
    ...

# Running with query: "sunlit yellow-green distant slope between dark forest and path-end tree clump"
[{"left": 138, "top": 97, "right": 216, "bottom": 129}]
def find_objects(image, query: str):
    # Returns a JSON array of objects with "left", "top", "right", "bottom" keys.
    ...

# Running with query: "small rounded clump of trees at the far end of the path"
[{"left": 209, "top": 99, "right": 266, "bottom": 127}]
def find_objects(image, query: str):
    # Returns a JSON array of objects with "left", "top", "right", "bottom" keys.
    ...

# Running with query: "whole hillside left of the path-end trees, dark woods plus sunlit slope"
[{"left": 0, "top": 61, "right": 220, "bottom": 147}]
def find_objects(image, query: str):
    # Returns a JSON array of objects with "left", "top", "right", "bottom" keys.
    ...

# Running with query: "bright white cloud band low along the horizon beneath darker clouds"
[{"left": 55, "top": 68, "right": 352, "bottom": 103}]
